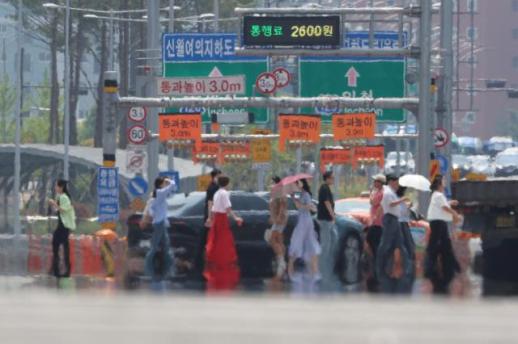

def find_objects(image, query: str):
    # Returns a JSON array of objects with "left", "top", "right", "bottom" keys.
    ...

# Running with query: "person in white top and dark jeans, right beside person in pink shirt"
[{"left": 376, "top": 175, "right": 409, "bottom": 293}]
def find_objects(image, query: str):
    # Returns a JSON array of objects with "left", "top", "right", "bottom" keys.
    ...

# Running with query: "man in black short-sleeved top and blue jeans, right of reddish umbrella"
[{"left": 317, "top": 171, "right": 338, "bottom": 278}]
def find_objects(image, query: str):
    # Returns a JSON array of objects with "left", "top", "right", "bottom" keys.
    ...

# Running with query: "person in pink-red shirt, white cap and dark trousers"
[{"left": 366, "top": 174, "right": 387, "bottom": 290}]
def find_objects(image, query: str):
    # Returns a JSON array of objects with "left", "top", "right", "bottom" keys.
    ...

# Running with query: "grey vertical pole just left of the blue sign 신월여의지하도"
[{"left": 146, "top": 0, "right": 160, "bottom": 185}]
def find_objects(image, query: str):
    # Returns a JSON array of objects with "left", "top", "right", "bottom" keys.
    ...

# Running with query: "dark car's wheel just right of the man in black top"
[{"left": 338, "top": 234, "right": 362, "bottom": 284}]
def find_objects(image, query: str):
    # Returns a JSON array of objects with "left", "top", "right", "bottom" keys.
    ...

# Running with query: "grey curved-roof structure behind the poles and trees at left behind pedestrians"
[{"left": 0, "top": 144, "right": 207, "bottom": 230}]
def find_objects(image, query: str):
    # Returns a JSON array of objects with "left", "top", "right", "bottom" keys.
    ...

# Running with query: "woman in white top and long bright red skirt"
[{"left": 204, "top": 176, "right": 243, "bottom": 284}]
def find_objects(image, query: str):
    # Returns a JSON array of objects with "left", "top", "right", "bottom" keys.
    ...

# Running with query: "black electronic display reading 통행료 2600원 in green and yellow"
[{"left": 242, "top": 15, "right": 342, "bottom": 49}]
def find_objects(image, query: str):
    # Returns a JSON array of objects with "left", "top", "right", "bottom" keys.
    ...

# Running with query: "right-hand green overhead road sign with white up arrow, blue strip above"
[{"left": 299, "top": 32, "right": 405, "bottom": 122}]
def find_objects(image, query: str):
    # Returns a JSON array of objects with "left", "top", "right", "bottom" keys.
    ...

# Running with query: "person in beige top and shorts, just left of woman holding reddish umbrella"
[{"left": 268, "top": 176, "right": 288, "bottom": 278}]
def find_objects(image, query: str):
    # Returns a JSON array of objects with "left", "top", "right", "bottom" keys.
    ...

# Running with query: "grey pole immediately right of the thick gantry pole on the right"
[{"left": 437, "top": 0, "right": 458, "bottom": 188}]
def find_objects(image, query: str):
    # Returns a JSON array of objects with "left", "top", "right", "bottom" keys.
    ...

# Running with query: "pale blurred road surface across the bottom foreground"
[{"left": 0, "top": 290, "right": 518, "bottom": 344}]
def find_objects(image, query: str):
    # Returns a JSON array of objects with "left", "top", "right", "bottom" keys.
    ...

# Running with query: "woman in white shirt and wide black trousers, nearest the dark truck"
[{"left": 425, "top": 175, "right": 460, "bottom": 294}]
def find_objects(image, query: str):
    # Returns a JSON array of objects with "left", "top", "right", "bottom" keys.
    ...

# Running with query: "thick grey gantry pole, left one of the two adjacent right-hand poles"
[{"left": 417, "top": 0, "right": 433, "bottom": 214}]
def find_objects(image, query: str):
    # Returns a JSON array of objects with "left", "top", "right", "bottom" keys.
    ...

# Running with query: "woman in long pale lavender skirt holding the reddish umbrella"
[{"left": 288, "top": 179, "right": 322, "bottom": 279}]
